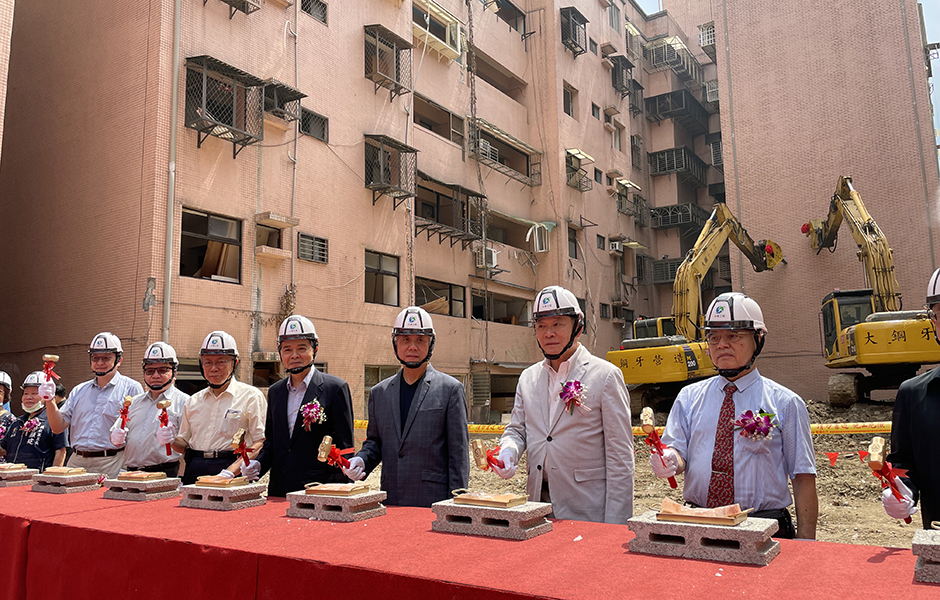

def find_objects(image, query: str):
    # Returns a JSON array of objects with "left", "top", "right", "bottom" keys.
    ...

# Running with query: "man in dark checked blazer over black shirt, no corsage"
[{"left": 343, "top": 306, "right": 470, "bottom": 506}]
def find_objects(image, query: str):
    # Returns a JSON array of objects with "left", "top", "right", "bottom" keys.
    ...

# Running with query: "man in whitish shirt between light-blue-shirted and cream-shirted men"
[{"left": 111, "top": 342, "right": 189, "bottom": 477}]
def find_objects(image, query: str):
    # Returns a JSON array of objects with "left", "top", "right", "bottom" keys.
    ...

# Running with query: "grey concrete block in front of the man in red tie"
[{"left": 627, "top": 510, "right": 780, "bottom": 565}]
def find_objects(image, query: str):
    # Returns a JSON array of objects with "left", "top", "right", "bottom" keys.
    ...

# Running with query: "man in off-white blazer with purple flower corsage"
[{"left": 496, "top": 286, "right": 634, "bottom": 523}]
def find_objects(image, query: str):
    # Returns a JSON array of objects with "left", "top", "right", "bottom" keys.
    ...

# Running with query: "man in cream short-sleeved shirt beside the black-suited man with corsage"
[{"left": 167, "top": 331, "right": 267, "bottom": 485}]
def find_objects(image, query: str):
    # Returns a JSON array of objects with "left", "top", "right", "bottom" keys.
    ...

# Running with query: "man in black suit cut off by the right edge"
[{"left": 881, "top": 269, "right": 940, "bottom": 530}]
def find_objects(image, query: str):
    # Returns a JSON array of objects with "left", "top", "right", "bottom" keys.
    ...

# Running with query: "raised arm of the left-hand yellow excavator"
[{"left": 672, "top": 202, "right": 783, "bottom": 340}]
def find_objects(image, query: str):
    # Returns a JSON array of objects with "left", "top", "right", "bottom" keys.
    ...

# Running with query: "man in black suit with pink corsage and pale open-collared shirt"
[{"left": 241, "top": 315, "right": 353, "bottom": 496}]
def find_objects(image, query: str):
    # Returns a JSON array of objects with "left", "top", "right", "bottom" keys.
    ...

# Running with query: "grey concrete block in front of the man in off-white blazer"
[{"left": 431, "top": 500, "right": 552, "bottom": 540}]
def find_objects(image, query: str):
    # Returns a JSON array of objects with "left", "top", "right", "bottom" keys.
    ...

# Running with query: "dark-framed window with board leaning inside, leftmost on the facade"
[{"left": 180, "top": 208, "right": 242, "bottom": 283}]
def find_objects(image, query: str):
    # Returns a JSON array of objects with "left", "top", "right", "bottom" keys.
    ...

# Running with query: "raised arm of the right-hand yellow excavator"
[{"left": 803, "top": 176, "right": 901, "bottom": 312}]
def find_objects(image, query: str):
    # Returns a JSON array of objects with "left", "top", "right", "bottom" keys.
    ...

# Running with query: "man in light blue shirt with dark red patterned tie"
[{"left": 650, "top": 292, "right": 819, "bottom": 539}]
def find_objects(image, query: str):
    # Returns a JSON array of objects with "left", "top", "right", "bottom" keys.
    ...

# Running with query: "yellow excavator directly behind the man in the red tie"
[{"left": 607, "top": 203, "right": 783, "bottom": 412}]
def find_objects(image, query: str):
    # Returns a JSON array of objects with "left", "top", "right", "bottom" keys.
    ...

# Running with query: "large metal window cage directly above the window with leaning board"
[{"left": 185, "top": 56, "right": 264, "bottom": 158}]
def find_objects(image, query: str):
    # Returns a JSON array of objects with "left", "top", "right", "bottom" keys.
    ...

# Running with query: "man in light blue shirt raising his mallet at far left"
[{"left": 39, "top": 331, "right": 144, "bottom": 478}]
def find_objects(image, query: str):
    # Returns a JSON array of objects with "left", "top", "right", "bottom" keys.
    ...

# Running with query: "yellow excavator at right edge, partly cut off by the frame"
[{"left": 803, "top": 176, "right": 940, "bottom": 406}]
